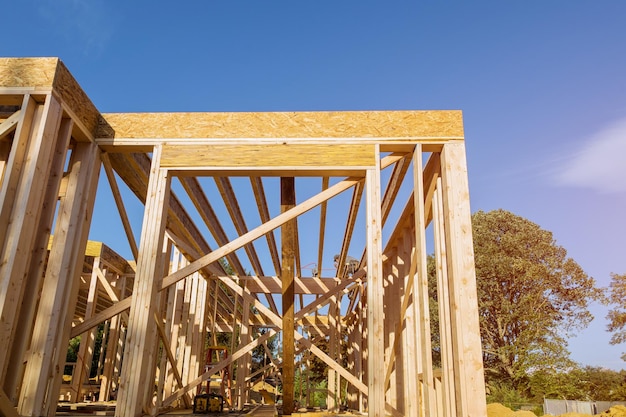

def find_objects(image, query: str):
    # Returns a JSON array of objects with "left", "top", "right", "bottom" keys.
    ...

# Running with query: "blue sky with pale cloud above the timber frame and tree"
[{"left": 0, "top": 0, "right": 626, "bottom": 369}]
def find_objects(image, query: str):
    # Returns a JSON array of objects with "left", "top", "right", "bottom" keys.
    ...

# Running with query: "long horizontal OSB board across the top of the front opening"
[{"left": 96, "top": 110, "right": 463, "bottom": 139}]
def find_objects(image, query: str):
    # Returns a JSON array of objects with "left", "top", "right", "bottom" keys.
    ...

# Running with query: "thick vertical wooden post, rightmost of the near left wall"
[{"left": 18, "top": 142, "right": 100, "bottom": 416}]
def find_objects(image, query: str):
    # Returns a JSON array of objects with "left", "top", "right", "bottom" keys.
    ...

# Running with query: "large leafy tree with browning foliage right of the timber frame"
[{"left": 472, "top": 210, "right": 602, "bottom": 391}]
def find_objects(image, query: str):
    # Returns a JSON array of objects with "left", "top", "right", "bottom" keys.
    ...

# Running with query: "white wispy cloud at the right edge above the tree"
[{"left": 555, "top": 118, "right": 626, "bottom": 193}]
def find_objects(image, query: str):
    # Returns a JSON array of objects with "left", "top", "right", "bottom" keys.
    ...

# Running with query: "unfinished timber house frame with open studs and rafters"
[{"left": 0, "top": 58, "right": 486, "bottom": 417}]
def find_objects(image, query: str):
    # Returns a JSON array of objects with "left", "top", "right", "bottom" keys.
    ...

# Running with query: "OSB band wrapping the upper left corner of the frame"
[{"left": 0, "top": 58, "right": 100, "bottom": 135}]
